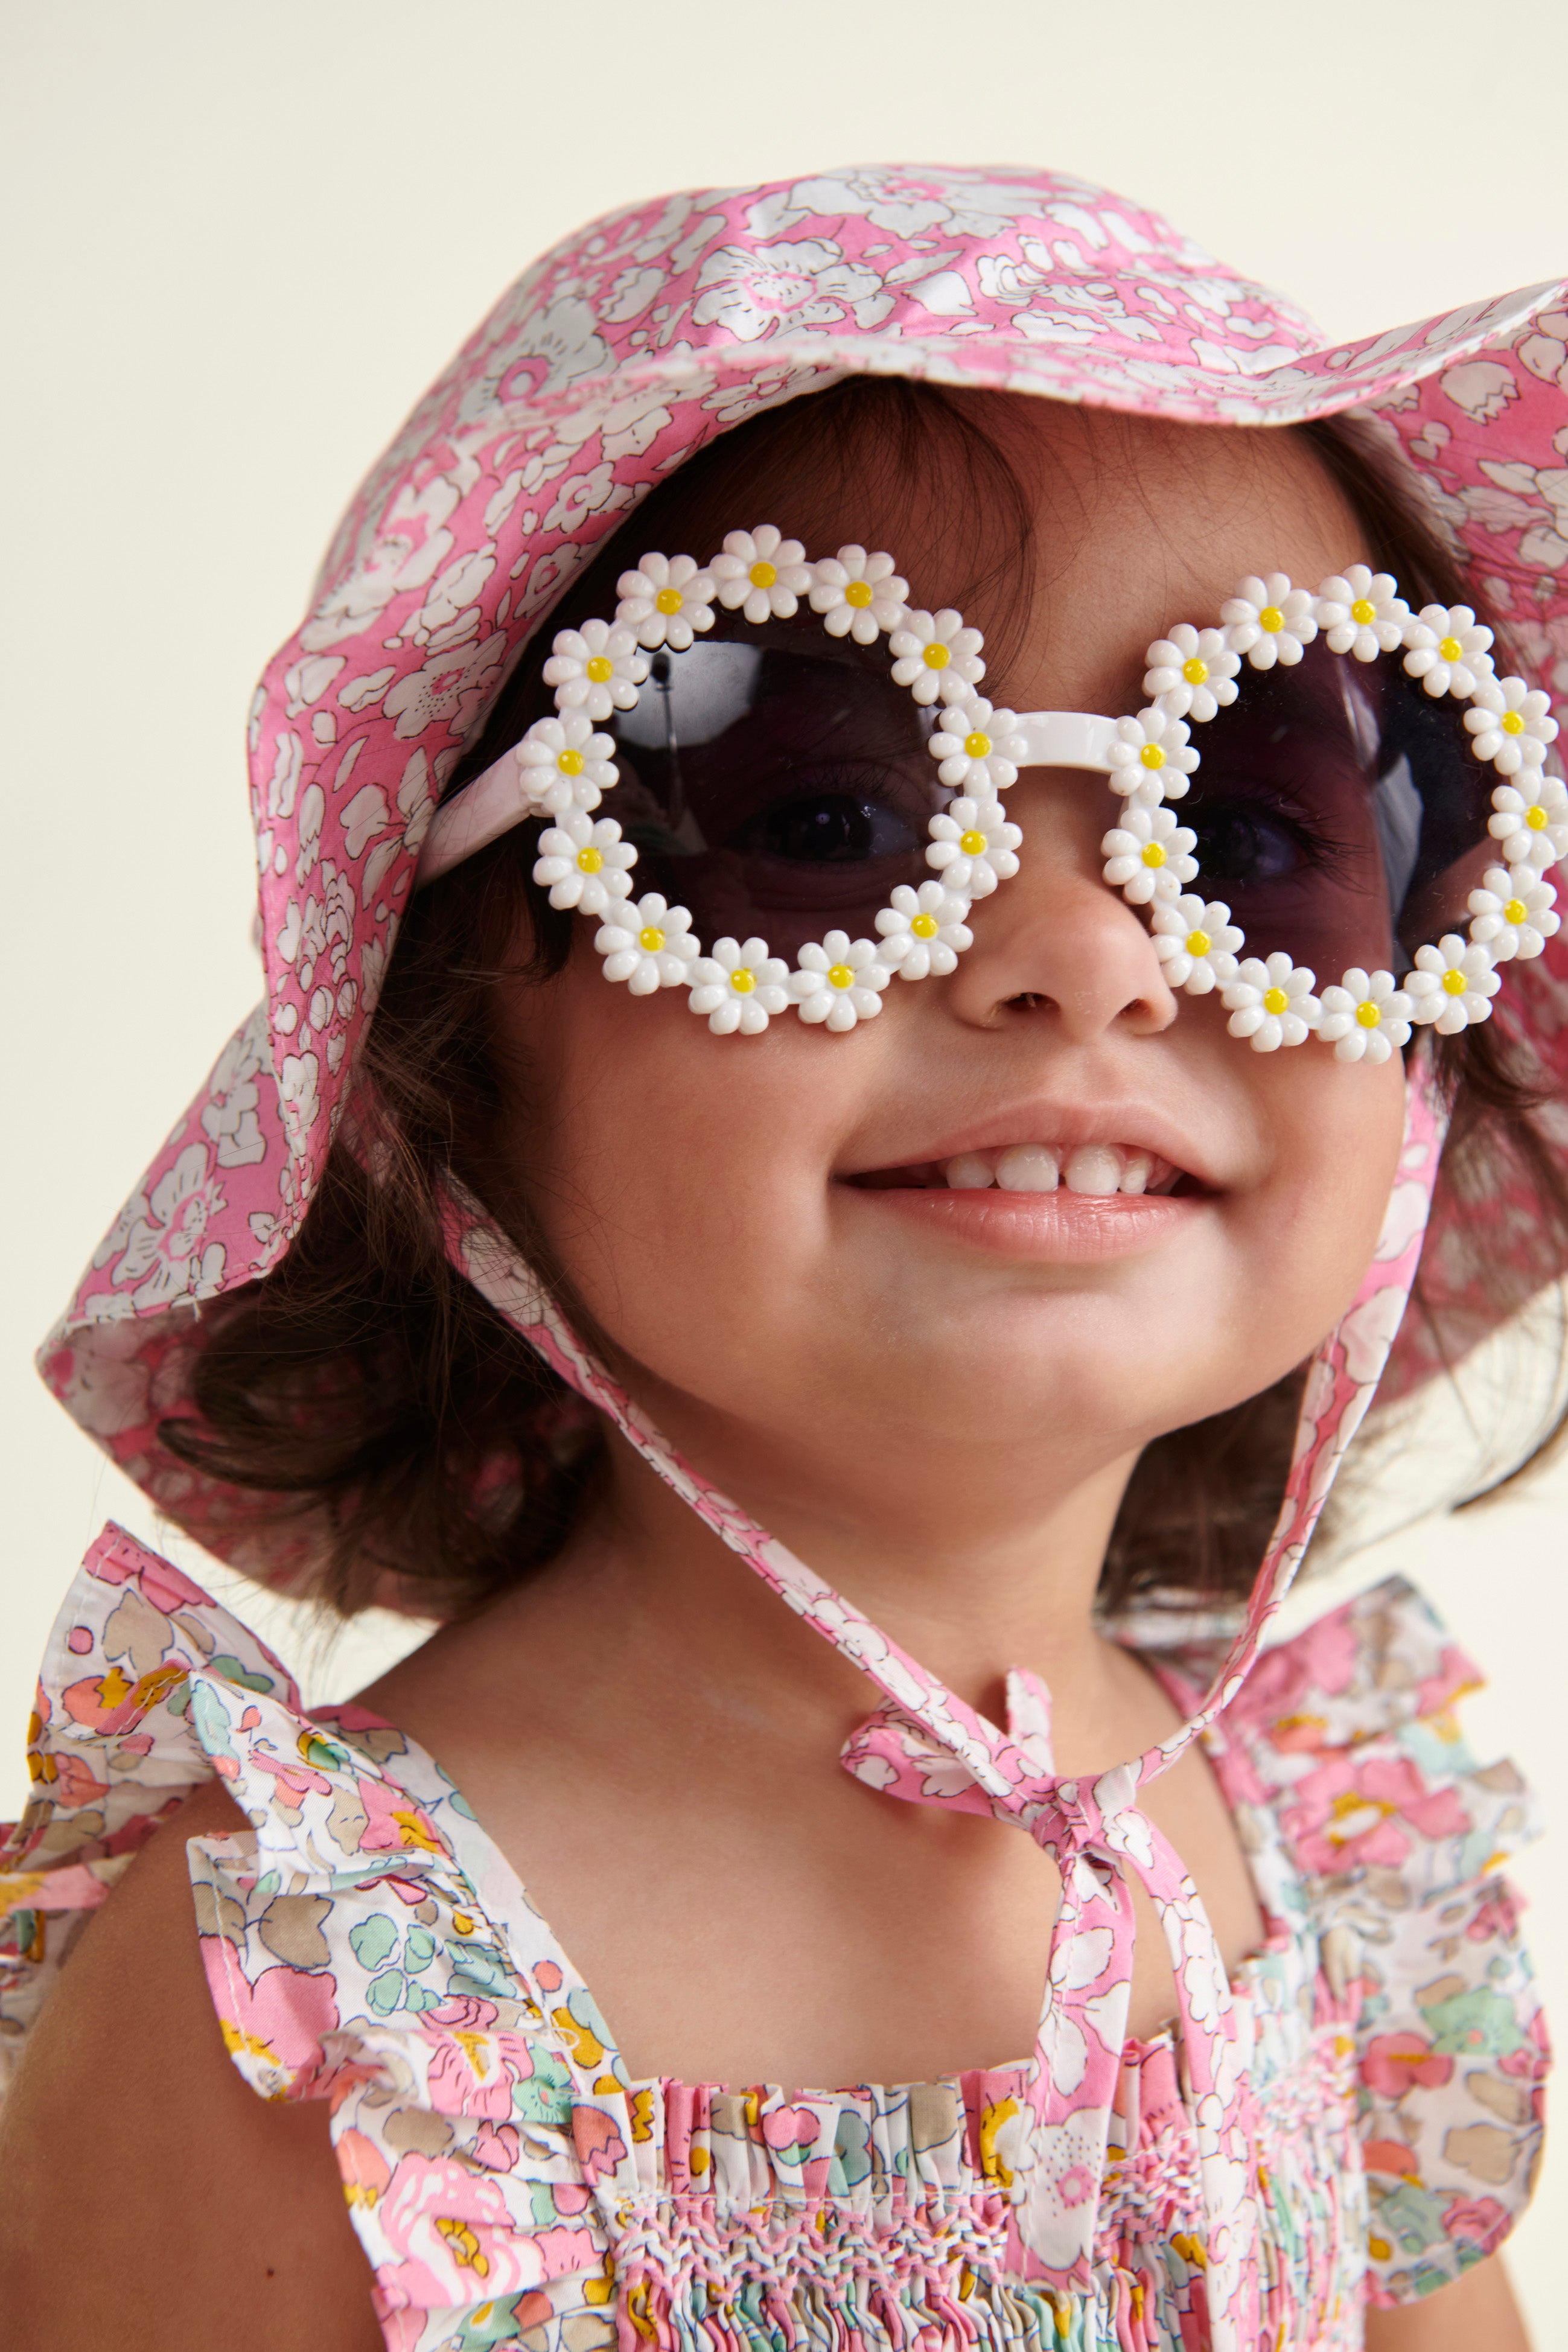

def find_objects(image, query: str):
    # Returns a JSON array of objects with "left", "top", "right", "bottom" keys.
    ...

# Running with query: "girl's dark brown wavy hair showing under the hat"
[{"left": 160, "top": 378, "right": 1568, "bottom": 1616}]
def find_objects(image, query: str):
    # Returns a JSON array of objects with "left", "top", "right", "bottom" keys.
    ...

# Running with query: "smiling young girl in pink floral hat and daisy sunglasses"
[{"left": 0, "top": 170, "right": 1568, "bottom": 2352}]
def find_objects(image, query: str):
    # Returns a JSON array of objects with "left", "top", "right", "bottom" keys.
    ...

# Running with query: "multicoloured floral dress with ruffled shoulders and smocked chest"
[{"left": 0, "top": 1529, "right": 1547, "bottom": 2352}]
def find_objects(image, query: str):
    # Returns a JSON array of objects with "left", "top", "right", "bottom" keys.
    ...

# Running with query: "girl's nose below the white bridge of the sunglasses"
[{"left": 948, "top": 769, "right": 1176, "bottom": 1044}]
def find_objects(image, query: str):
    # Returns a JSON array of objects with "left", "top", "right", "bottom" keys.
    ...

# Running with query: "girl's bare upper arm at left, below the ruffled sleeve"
[{"left": 0, "top": 1785, "right": 381, "bottom": 2352}]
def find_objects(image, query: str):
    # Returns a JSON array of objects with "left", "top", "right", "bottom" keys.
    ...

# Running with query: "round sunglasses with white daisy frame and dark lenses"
[{"left": 418, "top": 524, "right": 1568, "bottom": 1063}]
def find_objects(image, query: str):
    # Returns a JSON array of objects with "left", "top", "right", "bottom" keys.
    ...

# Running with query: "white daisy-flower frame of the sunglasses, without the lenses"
[{"left": 418, "top": 524, "right": 1568, "bottom": 1063}]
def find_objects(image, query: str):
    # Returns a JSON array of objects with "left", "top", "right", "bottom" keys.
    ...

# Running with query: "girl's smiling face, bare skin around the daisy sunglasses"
[{"left": 486, "top": 400, "right": 1403, "bottom": 1536}]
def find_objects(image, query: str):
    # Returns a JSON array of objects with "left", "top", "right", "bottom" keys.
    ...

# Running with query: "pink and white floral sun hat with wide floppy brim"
[{"left": 40, "top": 167, "right": 1568, "bottom": 1581}]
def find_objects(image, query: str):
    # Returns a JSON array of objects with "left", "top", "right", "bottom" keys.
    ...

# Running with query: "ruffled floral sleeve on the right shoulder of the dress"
[{"left": 1194, "top": 1578, "right": 1552, "bottom": 2303}]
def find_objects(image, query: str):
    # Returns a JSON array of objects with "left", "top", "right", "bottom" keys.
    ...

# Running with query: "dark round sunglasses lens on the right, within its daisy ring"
[{"left": 1176, "top": 640, "right": 1497, "bottom": 983}]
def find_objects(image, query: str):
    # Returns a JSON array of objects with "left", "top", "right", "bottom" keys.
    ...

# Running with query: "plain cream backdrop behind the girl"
[{"left": 0, "top": 0, "right": 1568, "bottom": 2347}]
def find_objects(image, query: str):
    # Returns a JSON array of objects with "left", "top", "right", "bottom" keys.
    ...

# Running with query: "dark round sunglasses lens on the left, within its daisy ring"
[{"left": 604, "top": 619, "right": 952, "bottom": 960}]
